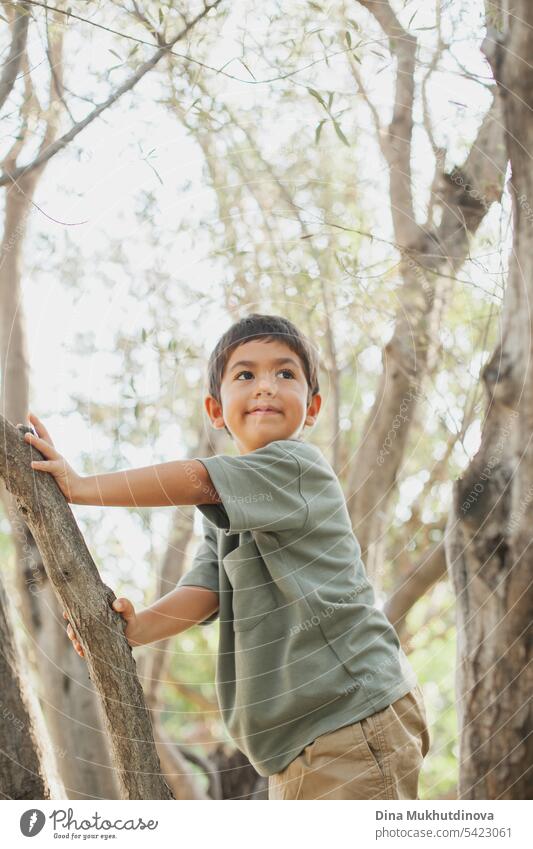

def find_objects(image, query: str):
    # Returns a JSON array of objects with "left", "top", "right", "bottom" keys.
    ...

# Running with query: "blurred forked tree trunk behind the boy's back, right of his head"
[{"left": 347, "top": 0, "right": 507, "bottom": 585}]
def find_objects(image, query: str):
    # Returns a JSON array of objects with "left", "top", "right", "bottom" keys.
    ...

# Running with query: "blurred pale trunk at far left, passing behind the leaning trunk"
[{"left": 0, "top": 176, "right": 118, "bottom": 799}]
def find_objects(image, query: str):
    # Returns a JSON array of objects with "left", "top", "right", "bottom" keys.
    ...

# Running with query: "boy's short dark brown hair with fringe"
[{"left": 207, "top": 313, "right": 320, "bottom": 404}]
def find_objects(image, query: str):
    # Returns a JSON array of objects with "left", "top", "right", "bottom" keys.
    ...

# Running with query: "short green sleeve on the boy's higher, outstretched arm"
[{"left": 195, "top": 440, "right": 309, "bottom": 534}]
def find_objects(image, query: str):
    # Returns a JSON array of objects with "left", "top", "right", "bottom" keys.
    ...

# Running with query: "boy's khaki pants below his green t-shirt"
[{"left": 268, "top": 685, "right": 430, "bottom": 799}]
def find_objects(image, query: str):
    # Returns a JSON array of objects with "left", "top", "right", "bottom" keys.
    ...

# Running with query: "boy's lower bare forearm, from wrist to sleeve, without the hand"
[{"left": 131, "top": 587, "right": 218, "bottom": 646}]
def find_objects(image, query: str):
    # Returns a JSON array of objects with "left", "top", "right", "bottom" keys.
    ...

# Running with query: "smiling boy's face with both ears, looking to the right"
[{"left": 204, "top": 339, "right": 322, "bottom": 454}]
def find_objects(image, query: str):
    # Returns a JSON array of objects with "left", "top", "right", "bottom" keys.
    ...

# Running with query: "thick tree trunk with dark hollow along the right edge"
[{"left": 446, "top": 0, "right": 533, "bottom": 799}]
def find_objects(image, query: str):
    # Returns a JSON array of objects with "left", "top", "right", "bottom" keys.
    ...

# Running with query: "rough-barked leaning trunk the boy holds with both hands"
[{"left": 0, "top": 416, "right": 172, "bottom": 799}]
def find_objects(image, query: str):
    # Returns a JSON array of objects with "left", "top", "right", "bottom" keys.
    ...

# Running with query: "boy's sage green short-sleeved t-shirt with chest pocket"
[{"left": 178, "top": 439, "right": 416, "bottom": 776}]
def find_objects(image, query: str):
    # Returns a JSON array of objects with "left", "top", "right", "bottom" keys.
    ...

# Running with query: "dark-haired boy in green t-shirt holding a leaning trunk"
[{"left": 25, "top": 314, "right": 429, "bottom": 799}]
